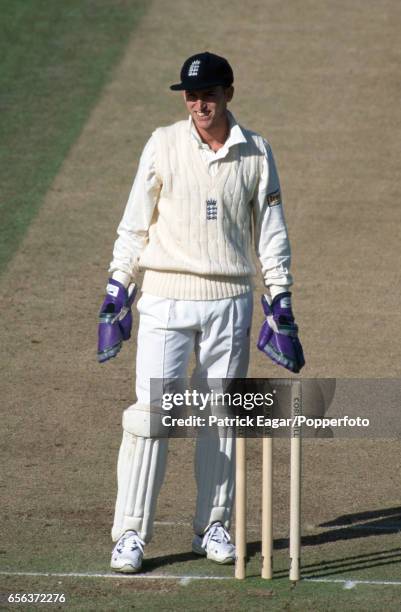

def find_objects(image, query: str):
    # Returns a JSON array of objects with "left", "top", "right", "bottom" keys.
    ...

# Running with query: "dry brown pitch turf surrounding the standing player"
[{"left": 0, "top": 0, "right": 401, "bottom": 608}]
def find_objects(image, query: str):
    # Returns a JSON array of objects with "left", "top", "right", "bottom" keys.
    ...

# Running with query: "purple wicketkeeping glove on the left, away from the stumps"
[{"left": 97, "top": 278, "right": 137, "bottom": 363}]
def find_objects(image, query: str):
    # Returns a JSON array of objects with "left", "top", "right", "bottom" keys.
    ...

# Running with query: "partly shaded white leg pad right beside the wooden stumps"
[{"left": 193, "top": 430, "right": 235, "bottom": 535}]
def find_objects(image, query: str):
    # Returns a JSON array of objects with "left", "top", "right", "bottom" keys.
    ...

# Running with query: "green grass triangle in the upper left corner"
[{"left": 0, "top": 0, "right": 149, "bottom": 272}]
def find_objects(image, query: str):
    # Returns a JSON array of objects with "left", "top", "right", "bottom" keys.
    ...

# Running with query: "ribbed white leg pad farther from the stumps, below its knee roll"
[{"left": 111, "top": 411, "right": 168, "bottom": 542}]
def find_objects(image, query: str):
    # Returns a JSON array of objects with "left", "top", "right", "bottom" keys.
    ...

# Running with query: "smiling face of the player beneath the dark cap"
[{"left": 184, "top": 85, "right": 234, "bottom": 132}]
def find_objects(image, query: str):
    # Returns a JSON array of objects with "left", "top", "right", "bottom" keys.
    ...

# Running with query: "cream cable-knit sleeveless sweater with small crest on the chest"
[{"left": 139, "top": 121, "right": 264, "bottom": 300}]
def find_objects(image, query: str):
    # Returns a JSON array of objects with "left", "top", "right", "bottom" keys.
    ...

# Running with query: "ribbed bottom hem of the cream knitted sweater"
[{"left": 142, "top": 270, "right": 253, "bottom": 300}]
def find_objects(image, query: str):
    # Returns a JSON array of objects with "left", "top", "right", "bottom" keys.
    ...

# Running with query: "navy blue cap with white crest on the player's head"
[{"left": 170, "top": 51, "right": 234, "bottom": 91}]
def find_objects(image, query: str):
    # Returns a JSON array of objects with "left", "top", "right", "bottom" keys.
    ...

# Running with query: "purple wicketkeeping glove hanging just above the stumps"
[{"left": 257, "top": 291, "right": 305, "bottom": 373}]
